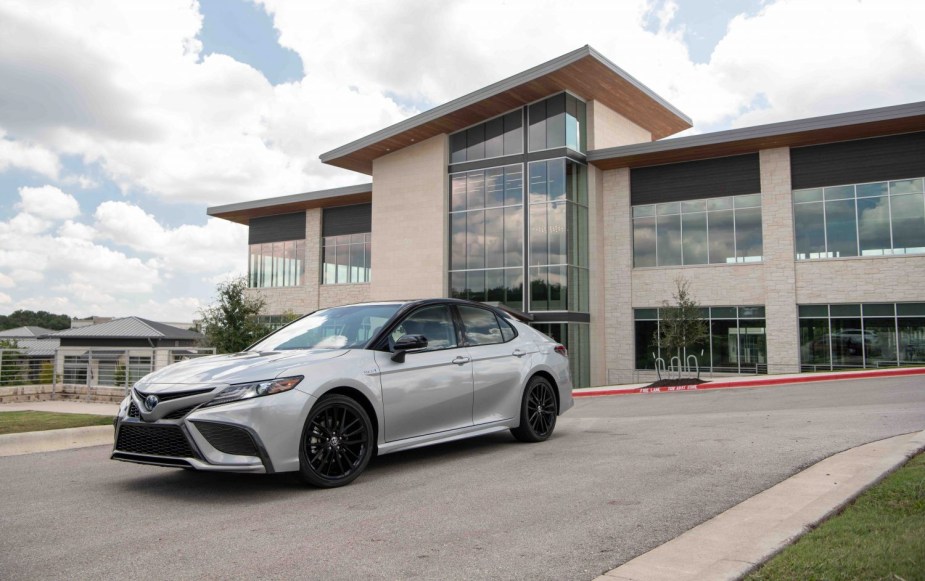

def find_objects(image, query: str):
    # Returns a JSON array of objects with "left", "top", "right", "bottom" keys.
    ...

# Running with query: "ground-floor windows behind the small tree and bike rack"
[{"left": 635, "top": 306, "right": 768, "bottom": 373}]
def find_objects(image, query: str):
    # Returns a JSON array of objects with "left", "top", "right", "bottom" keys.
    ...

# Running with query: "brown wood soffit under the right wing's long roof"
[{"left": 589, "top": 115, "right": 925, "bottom": 170}]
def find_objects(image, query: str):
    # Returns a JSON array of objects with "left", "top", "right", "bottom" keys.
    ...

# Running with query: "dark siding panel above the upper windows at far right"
[{"left": 790, "top": 132, "right": 925, "bottom": 189}]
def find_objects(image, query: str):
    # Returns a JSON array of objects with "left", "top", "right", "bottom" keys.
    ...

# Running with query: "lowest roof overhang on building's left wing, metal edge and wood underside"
[{"left": 206, "top": 183, "right": 373, "bottom": 225}]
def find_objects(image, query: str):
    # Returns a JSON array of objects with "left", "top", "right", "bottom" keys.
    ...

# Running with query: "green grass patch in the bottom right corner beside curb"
[{"left": 746, "top": 454, "right": 925, "bottom": 581}]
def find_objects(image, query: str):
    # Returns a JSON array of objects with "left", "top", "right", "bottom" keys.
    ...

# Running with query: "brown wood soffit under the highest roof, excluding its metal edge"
[{"left": 325, "top": 55, "right": 691, "bottom": 175}]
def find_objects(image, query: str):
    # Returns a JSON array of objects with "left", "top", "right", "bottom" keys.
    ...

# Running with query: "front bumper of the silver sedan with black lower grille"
[{"left": 111, "top": 390, "right": 312, "bottom": 473}]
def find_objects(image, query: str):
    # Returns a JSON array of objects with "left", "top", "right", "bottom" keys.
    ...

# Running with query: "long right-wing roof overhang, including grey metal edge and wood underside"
[{"left": 588, "top": 101, "right": 925, "bottom": 170}]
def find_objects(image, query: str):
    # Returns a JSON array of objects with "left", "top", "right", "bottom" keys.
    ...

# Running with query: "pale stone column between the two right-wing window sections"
[{"left": 758, "top": 147, "right": 800, "bottom": 373}]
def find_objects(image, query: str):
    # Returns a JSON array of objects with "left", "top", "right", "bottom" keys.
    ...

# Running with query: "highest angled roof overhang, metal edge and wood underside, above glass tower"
[{"left": 321, "top": 46, "right": 691, "bottom": 175}]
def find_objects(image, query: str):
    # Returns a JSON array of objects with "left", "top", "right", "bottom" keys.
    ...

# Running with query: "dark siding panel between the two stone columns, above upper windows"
[{"left": 630, "top": 153, "right": 761, "bottom": 205}]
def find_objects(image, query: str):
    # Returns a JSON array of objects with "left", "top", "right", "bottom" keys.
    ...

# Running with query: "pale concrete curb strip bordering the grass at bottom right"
[{"left": 595, "top": 431, "right": 925, "bottom": 581}]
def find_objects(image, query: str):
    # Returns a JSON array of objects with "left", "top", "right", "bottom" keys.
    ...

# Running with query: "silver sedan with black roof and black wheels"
[{"left": 112, "top": 299, "right": 573, "bottom": 487}]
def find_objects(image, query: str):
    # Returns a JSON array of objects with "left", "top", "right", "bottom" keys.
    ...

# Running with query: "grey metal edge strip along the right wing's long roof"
[{"left": 587, "top": 101, "right": 925, "bottom": 162}]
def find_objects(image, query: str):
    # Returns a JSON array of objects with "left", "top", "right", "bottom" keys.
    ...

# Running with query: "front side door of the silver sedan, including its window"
[{"left": 376, "top": 304, "right": 472, "bottom": 442}]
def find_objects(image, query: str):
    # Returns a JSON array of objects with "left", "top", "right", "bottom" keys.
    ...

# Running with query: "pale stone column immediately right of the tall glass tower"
[{"left": 592, "top": 168, "right": 636, "bottom": 384}]
